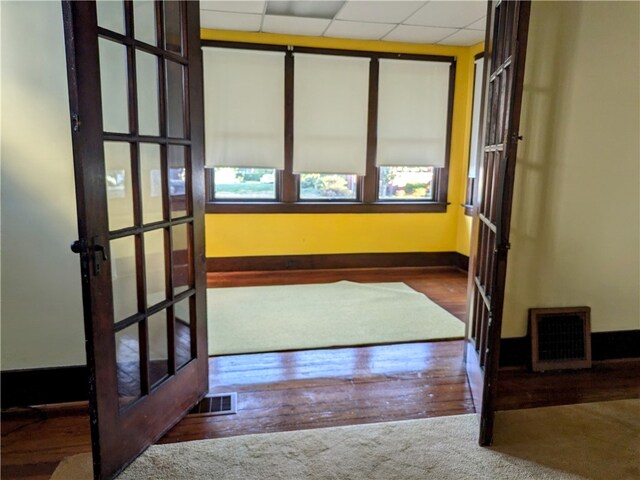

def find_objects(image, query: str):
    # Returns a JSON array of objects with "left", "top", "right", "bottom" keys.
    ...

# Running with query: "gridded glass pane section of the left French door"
[{"left": 97, "top": 2, "right": 196, "bottom": 408}]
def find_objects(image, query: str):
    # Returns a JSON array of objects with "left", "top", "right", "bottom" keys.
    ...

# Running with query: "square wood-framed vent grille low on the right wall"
[{"left": 529, "top": 307, "right": 591, "bottom": 371}]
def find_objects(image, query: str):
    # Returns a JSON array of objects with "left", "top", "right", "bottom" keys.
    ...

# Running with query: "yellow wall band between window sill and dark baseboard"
[{"left": 206, "top": 213, "right": 455, "bottom": 256}]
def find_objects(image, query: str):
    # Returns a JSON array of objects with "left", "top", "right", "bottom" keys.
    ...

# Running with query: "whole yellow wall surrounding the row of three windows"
[{"left": 201, "top": 30, "right": 477, "bottom": 257}]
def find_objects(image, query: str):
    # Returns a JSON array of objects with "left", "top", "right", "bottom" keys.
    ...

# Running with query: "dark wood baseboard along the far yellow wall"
[{"left": 207, "top": 252, "right": 469, "bottom": 272}]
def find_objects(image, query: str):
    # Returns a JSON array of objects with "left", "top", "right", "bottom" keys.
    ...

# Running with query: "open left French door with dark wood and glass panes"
[{"left": 62, "top": 1, "right": 208, "bottom": 479}]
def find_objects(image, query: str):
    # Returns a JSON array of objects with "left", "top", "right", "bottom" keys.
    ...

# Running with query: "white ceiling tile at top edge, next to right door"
[{"left": 404, "top": 0, "right": 487, "bottom": 28}]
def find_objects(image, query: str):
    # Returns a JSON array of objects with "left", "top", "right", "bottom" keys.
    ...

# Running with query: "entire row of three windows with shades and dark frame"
[{"left": 203, "top": 41, "right": 455, "bottom": 213}]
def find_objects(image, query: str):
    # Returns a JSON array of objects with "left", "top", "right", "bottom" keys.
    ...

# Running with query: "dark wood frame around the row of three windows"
[{"left": 202, "top": 40, "right": 456, "bottom": 213}]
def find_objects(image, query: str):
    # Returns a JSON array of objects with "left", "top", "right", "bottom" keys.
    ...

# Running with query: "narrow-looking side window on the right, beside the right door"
[{"left": 464, "top": 53, "right": 484, "bottom": 215}]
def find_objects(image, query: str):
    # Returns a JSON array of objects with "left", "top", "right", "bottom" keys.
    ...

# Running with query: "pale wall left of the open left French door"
[{"left": 0, "top": 1, "right": 85, "bottom": 370}]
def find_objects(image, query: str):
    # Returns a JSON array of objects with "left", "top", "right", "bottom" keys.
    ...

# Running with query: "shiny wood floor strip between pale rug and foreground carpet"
[{"left": 162, "top": 341, "right": 474, "bottom": 442}]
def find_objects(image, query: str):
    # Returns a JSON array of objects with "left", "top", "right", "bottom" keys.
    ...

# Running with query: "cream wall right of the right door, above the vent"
[{"left": 502, "top": 1, "right": 640, "bottom": 337}]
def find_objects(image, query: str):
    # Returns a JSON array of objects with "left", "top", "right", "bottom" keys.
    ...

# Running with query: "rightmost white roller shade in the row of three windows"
[{"left": 376, "top": 59, "right": 450, "bottom": 168}]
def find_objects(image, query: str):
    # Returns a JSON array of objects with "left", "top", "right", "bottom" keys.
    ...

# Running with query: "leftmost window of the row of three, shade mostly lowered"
[{"left": 203, "top": 48, "right": 284, "bottom": 201}]
